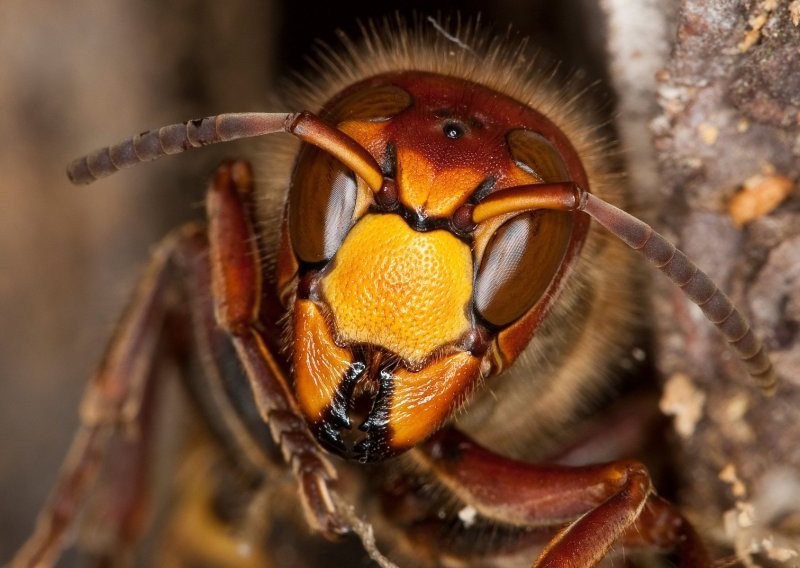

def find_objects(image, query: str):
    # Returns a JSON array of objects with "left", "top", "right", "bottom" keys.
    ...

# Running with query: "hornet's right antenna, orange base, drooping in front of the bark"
[{"left": 472, "top": 182, "right": 777, "bottom": 395}]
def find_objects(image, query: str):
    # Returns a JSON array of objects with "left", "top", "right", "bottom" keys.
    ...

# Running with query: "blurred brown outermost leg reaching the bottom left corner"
[{"left": 11, "top": 224, "right": 195, "bottom": 568}]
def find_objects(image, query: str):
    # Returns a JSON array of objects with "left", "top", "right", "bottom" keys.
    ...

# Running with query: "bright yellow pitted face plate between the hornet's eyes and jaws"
[{"left": 322, "top": 215, "right": 472, "bottom": 366}]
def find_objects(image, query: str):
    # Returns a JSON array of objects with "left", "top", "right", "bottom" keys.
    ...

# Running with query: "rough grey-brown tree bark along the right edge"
[{"left": 602, "top": 0, "right": 800, "bottom": 565}]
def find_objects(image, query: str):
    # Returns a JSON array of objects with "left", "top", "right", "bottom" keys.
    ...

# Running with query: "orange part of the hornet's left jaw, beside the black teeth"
[{"left": 293, "top": 300, "right": 352, "bottom": 422}]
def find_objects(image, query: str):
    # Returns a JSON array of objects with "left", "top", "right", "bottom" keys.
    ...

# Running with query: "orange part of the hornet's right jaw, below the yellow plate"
[{"left": 388, "top": 352, "right": 481, "bottom": 451}]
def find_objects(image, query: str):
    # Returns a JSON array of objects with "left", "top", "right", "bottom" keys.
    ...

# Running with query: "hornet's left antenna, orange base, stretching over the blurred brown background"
[{"left": 67, "top": 112, "right": 383, "bottom": 192}]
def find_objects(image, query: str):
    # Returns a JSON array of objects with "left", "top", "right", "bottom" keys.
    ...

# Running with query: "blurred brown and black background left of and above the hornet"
[{"left": 0, "top": 0, "right": 612, "bottom": 563}]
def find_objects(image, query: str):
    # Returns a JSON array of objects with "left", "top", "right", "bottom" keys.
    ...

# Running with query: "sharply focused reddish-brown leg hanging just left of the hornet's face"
[{"left": 207, "top": 162, "right": 350, "bottom": 537}]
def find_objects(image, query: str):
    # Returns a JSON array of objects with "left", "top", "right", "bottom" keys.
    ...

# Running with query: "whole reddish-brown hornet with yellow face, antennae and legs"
[{"left": 13, "top": 22, "right": 775, "bottom": 567}]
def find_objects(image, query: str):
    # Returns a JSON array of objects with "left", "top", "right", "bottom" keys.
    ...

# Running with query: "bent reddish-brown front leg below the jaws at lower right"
[{"left": 417, "top": 429, "right": 712, "bottom": 568}]
